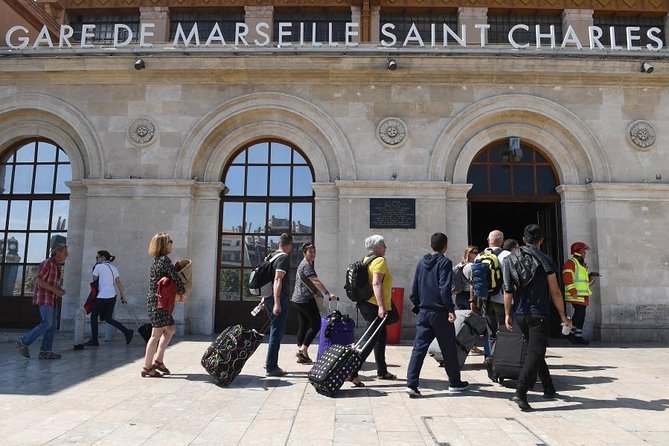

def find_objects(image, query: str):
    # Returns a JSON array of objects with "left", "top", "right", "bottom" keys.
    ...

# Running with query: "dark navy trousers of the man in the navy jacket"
[{"left": 407, "top": 310, "right": 462, "bottom": 388}]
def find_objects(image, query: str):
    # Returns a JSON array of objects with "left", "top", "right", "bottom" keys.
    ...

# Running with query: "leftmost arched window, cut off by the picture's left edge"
[{"left": 0, "top": 140, "right": 72, "bottom": 326}]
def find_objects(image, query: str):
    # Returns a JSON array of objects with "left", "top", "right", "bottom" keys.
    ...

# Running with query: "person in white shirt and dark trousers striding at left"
[{"left": 84, "top": 251, "right": 133, "bottom": 347}]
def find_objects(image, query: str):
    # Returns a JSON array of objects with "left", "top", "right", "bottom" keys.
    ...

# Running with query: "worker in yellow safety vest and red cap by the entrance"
[{"left": 562, "top": 242, "right": 599, "bottom": 345}]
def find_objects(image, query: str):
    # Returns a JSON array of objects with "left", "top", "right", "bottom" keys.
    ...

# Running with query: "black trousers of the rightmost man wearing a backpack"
[{"left": 516, "top": 315, "right": 555, "bottom": 397}]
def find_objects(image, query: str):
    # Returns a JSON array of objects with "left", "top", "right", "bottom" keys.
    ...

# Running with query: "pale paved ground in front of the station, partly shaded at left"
[{"left": 0, "top": 333, "right": 669, "bottom": 446}]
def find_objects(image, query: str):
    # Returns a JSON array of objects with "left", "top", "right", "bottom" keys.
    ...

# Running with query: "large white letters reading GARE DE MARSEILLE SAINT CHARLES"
[{"left": 5, "top": 22, "right": 664, "bottom": 51}]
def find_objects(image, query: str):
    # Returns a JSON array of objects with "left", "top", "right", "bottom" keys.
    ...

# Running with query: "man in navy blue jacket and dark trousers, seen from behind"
[{"left": 406, "top": 232, "right": 469, "bottom": 398}]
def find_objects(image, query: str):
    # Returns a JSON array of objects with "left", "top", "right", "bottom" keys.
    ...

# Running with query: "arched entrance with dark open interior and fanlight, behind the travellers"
[{"left": 467, "top": 140, "right": 564, "bottom": 336}]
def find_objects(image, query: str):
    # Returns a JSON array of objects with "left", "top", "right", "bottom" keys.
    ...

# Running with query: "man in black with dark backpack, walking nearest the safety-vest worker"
[{"left": 502, "top": 225, "right": 571, "bottom": 411}]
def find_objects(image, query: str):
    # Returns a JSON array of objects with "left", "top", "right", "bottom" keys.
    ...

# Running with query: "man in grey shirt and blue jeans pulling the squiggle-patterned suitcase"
[{"left": 263, "top": 234, "right": 293, "bottom": 376}]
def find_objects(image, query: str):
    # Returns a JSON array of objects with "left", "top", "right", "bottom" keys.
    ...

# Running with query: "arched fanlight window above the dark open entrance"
[{"left": 467, "top": 140, "right": 558, "bottom": 201}]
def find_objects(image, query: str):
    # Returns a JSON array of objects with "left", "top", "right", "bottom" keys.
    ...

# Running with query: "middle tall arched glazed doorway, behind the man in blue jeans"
[{"left": 214, "top": 140, "right": 314, "bottom": 331}]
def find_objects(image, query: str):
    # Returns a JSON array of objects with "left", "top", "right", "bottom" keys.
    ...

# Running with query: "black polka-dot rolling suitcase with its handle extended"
[{"left": 308, "top": 316, "right": 387, "bottom": 397}]
